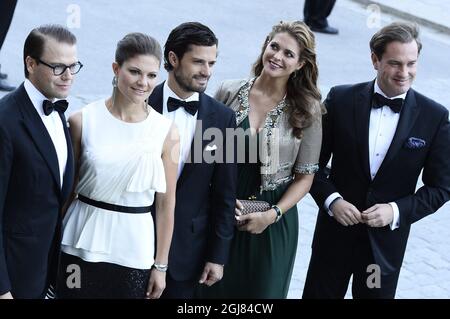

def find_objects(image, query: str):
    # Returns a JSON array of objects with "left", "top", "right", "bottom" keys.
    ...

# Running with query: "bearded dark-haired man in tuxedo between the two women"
[{"left": 149, "top": 22, "right": 237, "bottom": 299}]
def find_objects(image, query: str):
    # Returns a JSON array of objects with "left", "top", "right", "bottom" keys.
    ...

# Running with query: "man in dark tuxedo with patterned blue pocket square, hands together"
[{"left": 303, "top": 23, "right": 450, "bottom": 298}]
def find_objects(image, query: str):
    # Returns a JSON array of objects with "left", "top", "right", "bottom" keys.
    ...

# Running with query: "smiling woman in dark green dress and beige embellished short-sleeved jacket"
[{"left": 197, "top": 21, "right": 322, "bottom": 299}]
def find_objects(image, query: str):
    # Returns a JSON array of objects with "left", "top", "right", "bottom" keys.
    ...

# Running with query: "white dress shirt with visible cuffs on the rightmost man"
[{"left": 324, "top": 81, "right": 406, "bottom": 230}]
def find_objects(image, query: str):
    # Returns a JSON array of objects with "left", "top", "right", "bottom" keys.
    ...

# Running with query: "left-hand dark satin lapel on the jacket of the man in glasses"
[{"left": 17, "top": 85, "right": 60, "bottom": 189}]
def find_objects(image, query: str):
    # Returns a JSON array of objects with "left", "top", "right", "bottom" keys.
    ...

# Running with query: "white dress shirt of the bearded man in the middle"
[{"left": 162, "top": 81, "right": 199, "bottom": 178}]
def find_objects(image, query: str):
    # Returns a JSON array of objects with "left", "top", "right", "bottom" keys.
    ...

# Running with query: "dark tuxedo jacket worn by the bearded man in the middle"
[{"left": 149, "top": 83, "right": 237, "bottom": 281}]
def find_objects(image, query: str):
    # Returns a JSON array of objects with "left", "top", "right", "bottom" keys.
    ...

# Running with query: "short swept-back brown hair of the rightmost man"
[{"left": 370, "top": 22, "right": 422, "bottom": 60}]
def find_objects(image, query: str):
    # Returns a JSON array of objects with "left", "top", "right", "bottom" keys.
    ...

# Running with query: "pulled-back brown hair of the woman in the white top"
[{"left": 116, "top": 32, "right": 162, "bottom": 66}]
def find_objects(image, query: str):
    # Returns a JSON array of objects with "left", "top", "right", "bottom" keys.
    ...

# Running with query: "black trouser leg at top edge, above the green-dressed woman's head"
[{"left": 303, "top": 0, "right": 336, "bottom": 29}]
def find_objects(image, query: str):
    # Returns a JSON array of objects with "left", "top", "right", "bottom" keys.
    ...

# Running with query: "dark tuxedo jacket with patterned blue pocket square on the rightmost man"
[{"left": 311, "top": 81, "right": 450, "bottom": 274}]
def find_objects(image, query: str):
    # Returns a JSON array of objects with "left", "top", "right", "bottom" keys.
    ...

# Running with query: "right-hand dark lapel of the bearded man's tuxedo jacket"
[{"left": 178, "top": 93, "right": 215, "bottom": 185}]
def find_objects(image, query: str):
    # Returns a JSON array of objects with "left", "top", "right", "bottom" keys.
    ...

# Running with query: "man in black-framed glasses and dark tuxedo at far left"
[{"left": 0, "top": 25, "right": 81, "bottom": 298}]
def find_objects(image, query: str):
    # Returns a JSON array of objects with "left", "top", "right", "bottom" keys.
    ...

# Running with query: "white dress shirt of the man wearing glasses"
[{"left": 24, "top": 79, "right": 67, "bottom": 188}]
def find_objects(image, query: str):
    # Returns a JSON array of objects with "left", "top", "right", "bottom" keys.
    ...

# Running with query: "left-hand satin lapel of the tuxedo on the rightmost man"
[{"left": 354, "top": 81, "right": 374, "bottom": 184}]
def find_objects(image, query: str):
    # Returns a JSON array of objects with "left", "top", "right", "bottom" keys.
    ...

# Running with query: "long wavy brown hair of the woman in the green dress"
[{"left": 253, "top": 21, "right": 321, "bottom": 138}]
